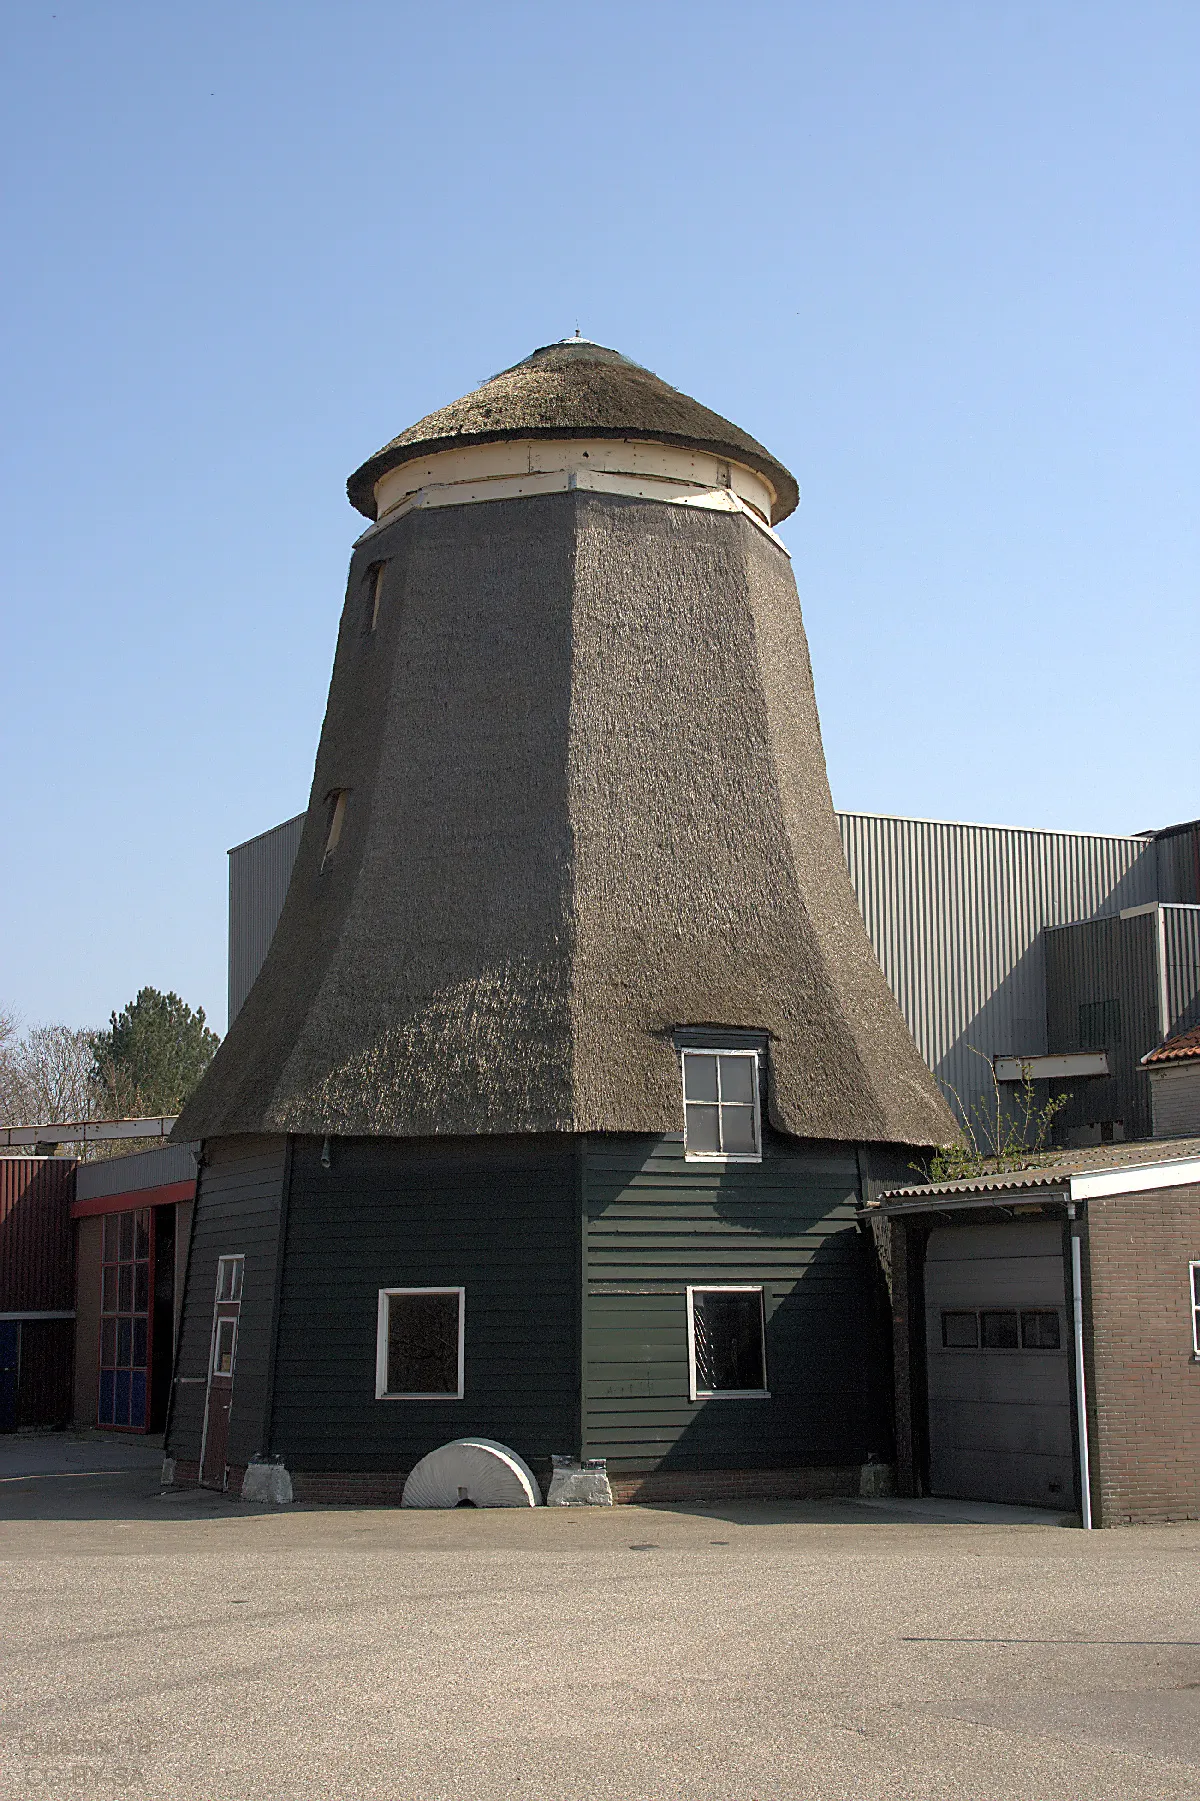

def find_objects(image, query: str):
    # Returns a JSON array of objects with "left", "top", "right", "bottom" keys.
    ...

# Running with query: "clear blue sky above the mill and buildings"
[{"left": 0, "top": 0, "right": 1200, "bottom": 1028}]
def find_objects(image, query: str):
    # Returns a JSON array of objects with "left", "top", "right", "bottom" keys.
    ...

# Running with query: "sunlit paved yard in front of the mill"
[{"left": 0, "top": 1439, "right": 1200, "bottom": 1801}]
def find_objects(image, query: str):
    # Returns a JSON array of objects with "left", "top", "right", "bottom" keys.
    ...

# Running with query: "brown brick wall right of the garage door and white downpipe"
[{"left": 1088, "top": 1185, "right": 1200, "bottom": 1525}]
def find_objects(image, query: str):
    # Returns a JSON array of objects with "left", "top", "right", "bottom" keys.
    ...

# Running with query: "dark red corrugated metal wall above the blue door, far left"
[{"left": 0, "top": 1156, "right": 76, "bottom": 1313}]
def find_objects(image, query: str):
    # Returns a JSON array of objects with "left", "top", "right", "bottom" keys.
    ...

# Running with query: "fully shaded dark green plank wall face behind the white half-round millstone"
[{"left": 270, "top": 1136, "right": 580, "bottom": 1477}]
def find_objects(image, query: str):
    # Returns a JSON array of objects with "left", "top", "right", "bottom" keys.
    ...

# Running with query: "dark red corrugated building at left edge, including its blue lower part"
[{"left": 0, "top": 1156, "right": 76, "bottom": 1432}]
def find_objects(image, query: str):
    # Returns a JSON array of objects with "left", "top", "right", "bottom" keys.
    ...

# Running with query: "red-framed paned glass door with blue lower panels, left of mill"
[{"left": 97, "top": 1207, "right": 153, "bottom": 1432}]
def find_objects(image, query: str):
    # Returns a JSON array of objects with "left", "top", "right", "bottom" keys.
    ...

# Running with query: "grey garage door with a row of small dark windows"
[{"left": 924, "top": 1221, "right": 1076, "bottom": 1507}]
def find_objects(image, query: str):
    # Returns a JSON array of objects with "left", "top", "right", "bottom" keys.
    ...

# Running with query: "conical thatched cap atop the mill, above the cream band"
[{"left": 346, "top": 339, "right": 800, "bottom": 524}]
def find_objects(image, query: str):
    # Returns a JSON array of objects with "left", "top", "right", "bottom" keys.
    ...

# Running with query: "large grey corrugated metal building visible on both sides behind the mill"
[{"left": 229, "top": 812, "right": 1200, "bottom": 1136}]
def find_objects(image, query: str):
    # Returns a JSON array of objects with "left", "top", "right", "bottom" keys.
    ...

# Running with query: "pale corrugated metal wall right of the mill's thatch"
[{"left": 838, "top": 812, "right": 1157, "bottom": 1109}]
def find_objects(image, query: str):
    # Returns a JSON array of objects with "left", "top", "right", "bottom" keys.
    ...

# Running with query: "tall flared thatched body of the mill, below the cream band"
[{"left": 177, "top": 464, "right": 955, "bottom": 1145}]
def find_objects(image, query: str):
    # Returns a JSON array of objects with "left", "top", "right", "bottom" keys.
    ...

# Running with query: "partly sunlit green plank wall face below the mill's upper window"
[{"left": 582, "top": 1135, "right": 890, "bottom": 1473}]
